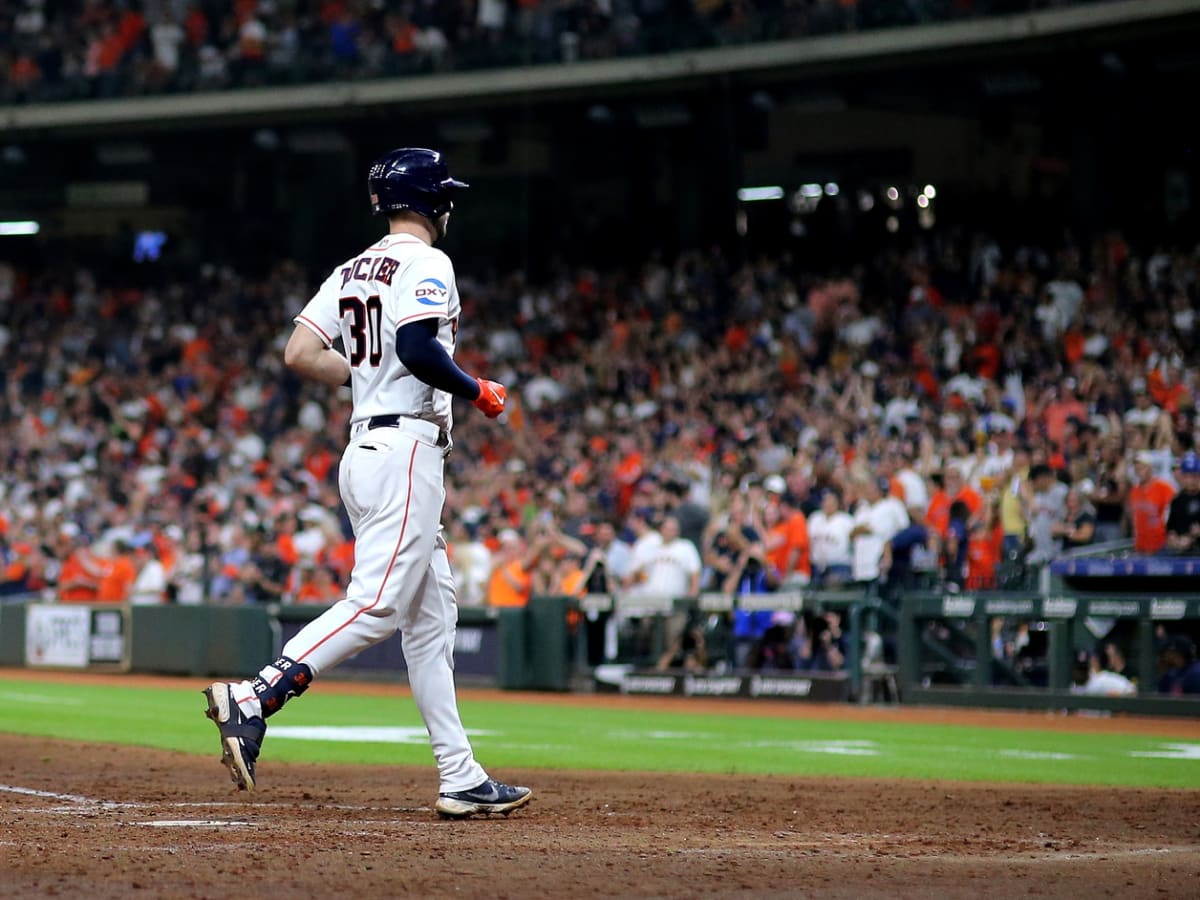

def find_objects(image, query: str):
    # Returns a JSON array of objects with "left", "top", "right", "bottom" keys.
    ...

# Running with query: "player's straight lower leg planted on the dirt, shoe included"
[{"left": 400, "top": 534, "right": 530, "bottom": 818}]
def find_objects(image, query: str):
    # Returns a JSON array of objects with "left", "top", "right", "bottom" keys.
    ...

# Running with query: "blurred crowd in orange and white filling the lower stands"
[{"left": 0, "top": 218, "right": 1200, "bottom": 691}]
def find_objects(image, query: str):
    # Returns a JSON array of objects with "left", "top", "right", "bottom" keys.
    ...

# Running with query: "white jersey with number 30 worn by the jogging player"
[{"left": 295, "top": 234, "right": 460, "bottom": 432}]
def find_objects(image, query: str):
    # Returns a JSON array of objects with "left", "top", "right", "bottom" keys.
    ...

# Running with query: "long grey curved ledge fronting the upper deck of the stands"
[{"left": 0, "top": 0, "right": 1200, "bottom": 138}]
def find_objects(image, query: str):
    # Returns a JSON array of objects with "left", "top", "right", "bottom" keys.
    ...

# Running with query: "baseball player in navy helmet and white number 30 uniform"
[{"left": 204, "top": 148, "right": 530, "bottom": 818}]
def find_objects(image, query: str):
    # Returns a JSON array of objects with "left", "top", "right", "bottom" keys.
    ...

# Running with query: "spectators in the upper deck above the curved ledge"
[{"left": 0, "top": 0, "right": 1094, "bottom": 102}]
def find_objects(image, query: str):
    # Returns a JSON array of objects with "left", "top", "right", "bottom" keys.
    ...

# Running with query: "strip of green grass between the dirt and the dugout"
[{"left": 0, "top": 679, "right": 1200, "bottom": 788}]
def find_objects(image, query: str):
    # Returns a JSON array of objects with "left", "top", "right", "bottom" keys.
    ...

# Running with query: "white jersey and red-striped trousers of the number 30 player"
[{"left": 225, "top": 234, "right": 487, "bottom": 792}]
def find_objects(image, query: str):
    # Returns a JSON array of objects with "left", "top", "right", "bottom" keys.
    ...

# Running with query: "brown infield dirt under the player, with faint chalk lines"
[{"left": 0, "top": 672, "right": 1200, "bottom": 900}]
